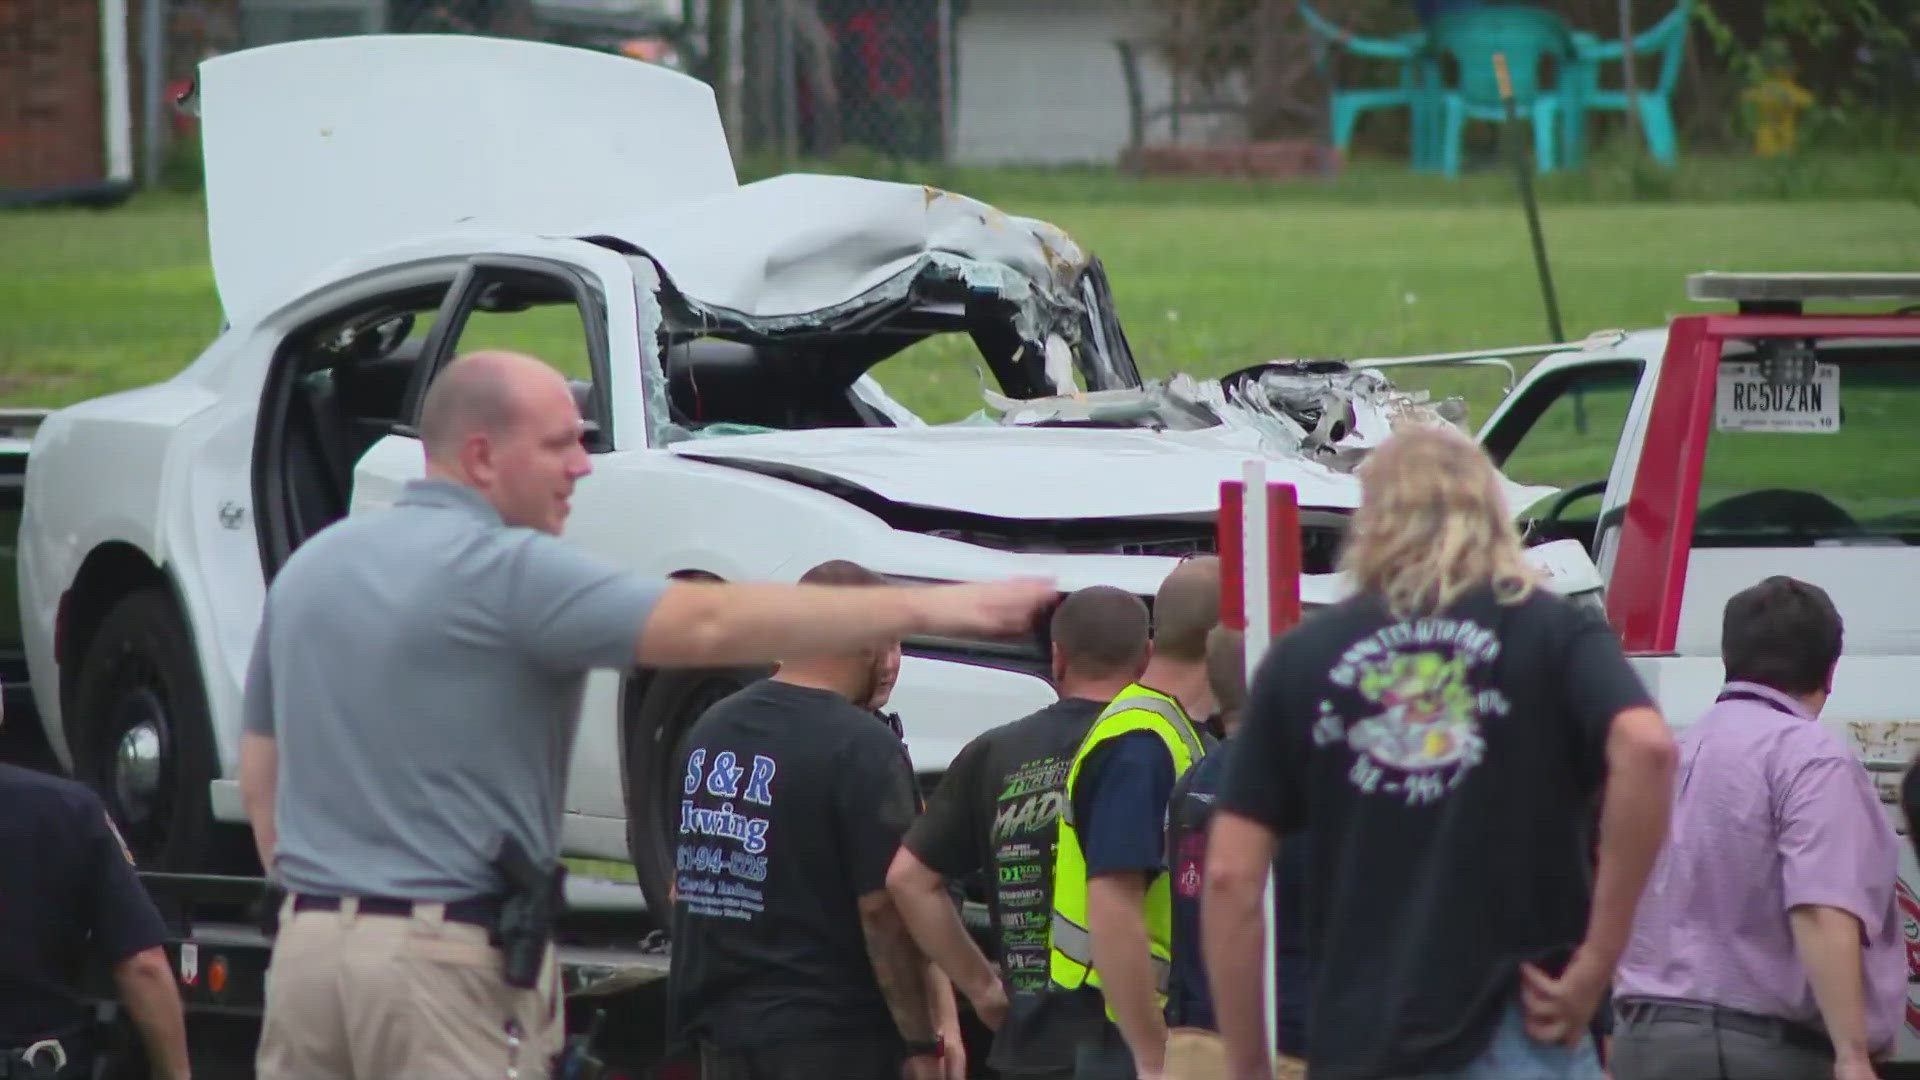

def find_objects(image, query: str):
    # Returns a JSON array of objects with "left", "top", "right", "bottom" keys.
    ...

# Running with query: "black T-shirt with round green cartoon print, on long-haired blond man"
[{"left": 1219, "top": 590, "right": 1649, "bottom": 1080}]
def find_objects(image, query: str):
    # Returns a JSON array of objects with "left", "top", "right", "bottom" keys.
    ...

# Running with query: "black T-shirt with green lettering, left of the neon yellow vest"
[{"left": 906, "top": 698, "right": 1106, "bottom": 992}]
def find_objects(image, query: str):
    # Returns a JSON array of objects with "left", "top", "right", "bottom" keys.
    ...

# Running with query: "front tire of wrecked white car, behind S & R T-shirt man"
[{"left": 624, "top": 667, "right": 774, "bottom": 930}]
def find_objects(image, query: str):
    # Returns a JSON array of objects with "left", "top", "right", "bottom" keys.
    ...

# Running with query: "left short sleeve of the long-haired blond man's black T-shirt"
[{"left": 1217, "top": 630, "right": 1313, "bottom": 836}]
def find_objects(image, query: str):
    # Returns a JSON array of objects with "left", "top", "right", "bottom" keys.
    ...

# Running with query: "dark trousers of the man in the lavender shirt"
[{"left": 1607, "top": 1001, "right": 1834, "bottom": 1080}]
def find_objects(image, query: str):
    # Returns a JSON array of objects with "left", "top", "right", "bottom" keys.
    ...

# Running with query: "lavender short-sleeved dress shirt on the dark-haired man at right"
[{"left": 1613, "top": 682, "right": 1907, "bottom": 1053}]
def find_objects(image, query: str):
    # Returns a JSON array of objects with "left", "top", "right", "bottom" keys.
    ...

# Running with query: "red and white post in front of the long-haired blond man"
[{"left": 1217, "top": 461, "right": 1300, "bottom": 1047}]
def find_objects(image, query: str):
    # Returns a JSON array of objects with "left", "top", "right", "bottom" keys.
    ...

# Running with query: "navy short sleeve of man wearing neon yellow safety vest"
[{"left": 1073, "top": 732, "right": 1173, "bottom": 876}]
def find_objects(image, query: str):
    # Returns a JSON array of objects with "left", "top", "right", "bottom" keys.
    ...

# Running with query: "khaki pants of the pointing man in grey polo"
[{"left": 255, "top": 899, "right": 564, "bottom": 1080}]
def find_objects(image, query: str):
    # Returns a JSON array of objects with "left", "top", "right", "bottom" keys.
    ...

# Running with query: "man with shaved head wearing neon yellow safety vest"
[{"left": 1048, "top": 555, "right": 1219, "bottom": 1080}]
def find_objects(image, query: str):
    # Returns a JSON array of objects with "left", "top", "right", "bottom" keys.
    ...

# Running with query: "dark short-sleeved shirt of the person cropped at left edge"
[{"left": 0, "top": 765, "right": 167, "bottom": 1047}]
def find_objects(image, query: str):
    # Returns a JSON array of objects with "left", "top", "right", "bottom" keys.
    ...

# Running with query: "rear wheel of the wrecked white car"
[{"left": 69, "top": 588, "right": 215, "bottom": 871}]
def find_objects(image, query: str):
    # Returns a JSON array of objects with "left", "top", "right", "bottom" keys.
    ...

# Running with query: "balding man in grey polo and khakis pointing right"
[{"left": 240, "top": 352, "right": 1054, "bottom": 1080}]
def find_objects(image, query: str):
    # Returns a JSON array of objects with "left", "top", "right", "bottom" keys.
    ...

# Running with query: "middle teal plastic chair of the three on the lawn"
[{"left": 1432, "top": 4, "right": 1578, "bottom": 177}]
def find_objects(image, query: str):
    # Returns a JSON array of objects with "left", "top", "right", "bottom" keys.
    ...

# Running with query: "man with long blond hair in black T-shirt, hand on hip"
[{"left": 1200, "top": 425, "right": 1674, "bottom": 1080}]
